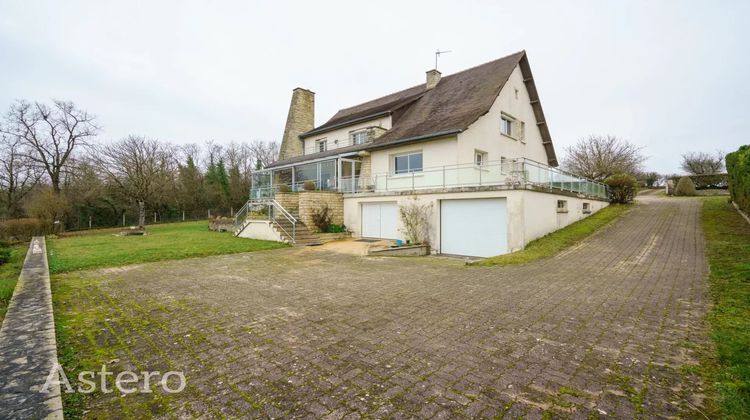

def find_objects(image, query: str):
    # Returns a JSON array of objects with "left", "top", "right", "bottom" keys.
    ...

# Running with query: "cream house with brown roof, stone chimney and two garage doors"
[{"left": 237, "top": 51, "right": 607, "bottom": 257}]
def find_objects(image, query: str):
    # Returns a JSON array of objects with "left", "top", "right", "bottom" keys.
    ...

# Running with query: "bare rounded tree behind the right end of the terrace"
[{"left": 562, "top": 135, "right": 646, "bottom": 181}]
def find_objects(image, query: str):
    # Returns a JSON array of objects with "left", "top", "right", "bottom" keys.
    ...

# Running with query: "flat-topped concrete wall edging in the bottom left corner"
[{"left": 0, "top": 236, "right": 63, "bottom": 419}]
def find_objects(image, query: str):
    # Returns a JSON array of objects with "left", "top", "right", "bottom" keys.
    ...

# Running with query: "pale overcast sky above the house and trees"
[{"left": 0, "top": 0, "right": 750, "bottom": 172}]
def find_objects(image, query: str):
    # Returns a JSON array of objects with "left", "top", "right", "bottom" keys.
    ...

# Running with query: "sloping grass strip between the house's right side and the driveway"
[{"left": 475, "top": 204, "right": 632, "bottom": 266}]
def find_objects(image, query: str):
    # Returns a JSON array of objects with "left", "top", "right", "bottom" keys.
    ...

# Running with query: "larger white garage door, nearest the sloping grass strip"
[{"left": 440, "top": 198, "right": 508, "bottom": 257}]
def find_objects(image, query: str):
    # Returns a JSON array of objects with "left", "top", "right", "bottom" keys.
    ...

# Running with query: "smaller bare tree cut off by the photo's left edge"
[{"left": 0, "top": 133, "right": 42, "bottom": 217}]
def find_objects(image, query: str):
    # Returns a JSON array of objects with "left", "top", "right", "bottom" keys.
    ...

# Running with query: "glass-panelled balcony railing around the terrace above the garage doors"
[{"left": 253, "top": 158, "right": 607, "bottom": 199}]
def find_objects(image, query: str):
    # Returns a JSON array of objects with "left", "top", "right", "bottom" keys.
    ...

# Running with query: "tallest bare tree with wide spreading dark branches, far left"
[{"left": 3, "top": 100, "right": 99, "bottom": 195}]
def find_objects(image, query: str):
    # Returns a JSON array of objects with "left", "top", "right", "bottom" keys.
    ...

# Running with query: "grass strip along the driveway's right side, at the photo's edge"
[{"left": 702, "top": 197, "right": 750, "bottom": 419}]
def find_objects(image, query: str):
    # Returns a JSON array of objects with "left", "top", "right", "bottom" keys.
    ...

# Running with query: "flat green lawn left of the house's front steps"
[{"left": 47, "top": 221, "right": 286, "bottom": 274}]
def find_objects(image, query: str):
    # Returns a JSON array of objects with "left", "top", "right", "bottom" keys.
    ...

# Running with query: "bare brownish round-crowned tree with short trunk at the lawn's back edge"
[{"left": 92, "top": 136, "right": 171, "bottom": 228}]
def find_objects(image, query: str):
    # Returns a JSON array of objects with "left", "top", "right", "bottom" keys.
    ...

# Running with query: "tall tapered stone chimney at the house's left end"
[{"left": 279, "top": 88, "right": 315, "bottom": 160}]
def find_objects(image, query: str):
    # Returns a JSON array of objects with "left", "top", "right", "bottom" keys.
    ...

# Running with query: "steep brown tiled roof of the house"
[{"left": 272, "top": 51, "right": 557, "bottom": 166}]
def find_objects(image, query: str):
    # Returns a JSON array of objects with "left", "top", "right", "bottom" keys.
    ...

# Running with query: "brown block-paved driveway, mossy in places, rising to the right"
[{"left": 57, "top": 197, "right": 708, "bottom": 418}]
